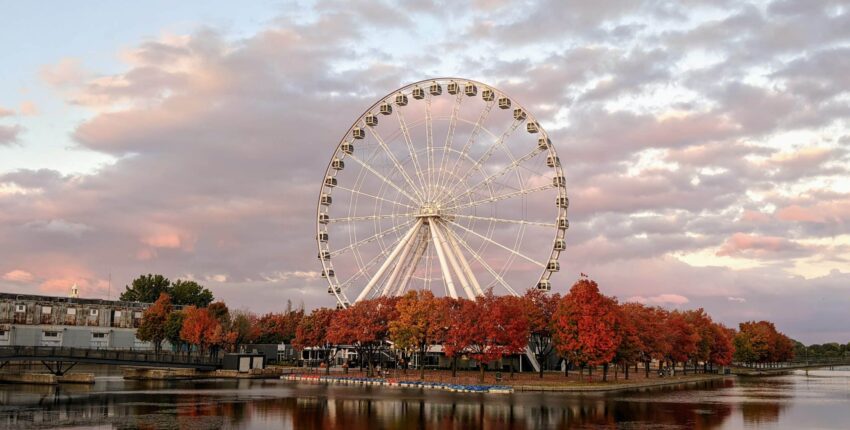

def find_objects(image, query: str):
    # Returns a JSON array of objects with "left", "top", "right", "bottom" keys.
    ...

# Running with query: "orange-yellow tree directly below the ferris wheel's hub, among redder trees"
[{"left": 389, "top": 290, "right": 448, "bottom": 379}]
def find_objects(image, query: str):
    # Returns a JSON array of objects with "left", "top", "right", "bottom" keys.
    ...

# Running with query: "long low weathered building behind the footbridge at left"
[{"left": 0, "top": 293, "right": 152, "bottom": 349}]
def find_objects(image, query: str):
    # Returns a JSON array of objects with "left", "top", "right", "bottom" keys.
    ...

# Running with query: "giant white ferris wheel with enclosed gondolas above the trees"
[{"left": 316, "top": 78, "right": 569, "bottom": 307}]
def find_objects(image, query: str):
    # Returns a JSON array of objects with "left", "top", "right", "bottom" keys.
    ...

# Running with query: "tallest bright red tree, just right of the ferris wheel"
[{"left": 554, "top": 279, "right": 620, "bottom": 381}]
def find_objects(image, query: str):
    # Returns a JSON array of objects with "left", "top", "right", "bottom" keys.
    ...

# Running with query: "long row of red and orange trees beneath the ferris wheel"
[{"left": 293, "top": 279, "right": 794, "bottom": 381}]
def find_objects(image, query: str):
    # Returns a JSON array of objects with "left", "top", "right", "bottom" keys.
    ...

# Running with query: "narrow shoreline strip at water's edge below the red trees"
[{"left": 280, "top": 374, "right": 735, "bottom": 394}]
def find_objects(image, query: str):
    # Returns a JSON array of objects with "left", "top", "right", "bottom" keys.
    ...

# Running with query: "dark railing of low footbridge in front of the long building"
[{"left": 0, "top": 346, "right": 221, "bottom": 366}]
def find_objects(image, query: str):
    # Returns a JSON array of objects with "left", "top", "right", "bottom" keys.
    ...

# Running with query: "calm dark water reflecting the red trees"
[{"left": 0, "top": 368, "right": 850, "bottom": 430}]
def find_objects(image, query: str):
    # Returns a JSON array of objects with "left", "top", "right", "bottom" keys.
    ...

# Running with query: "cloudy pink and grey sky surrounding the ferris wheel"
[{"left": 0, "top": 0, "right": 850, "bottom": 343}]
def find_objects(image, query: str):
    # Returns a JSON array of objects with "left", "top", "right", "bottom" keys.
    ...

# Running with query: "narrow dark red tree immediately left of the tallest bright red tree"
[{"left": 523, "top": 288, "right": 561, "bottom": 378}]
